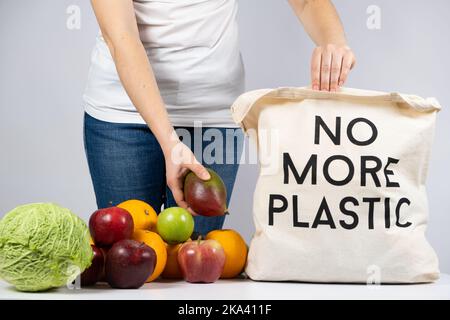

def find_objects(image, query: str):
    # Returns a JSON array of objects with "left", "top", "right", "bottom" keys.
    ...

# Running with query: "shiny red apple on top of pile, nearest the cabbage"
[{"left": 89, "top": 207, "right": 134, "bottom": 247}]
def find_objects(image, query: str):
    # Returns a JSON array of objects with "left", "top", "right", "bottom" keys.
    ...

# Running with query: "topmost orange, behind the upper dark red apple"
[{"left": 118, "top": 199, "right": 158, "bottom": 231}]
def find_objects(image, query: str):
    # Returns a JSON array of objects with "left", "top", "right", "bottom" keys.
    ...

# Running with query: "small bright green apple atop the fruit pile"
[{"left": 156, "top": 207, "right": 194, "bottom": 244}]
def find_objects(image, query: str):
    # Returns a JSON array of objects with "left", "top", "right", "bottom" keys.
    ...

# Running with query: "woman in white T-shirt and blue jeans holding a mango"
[{"left": 84, "top": 0, "right": 355, "bottom": 234}]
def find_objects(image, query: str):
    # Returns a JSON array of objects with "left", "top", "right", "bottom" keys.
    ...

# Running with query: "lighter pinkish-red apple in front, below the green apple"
[{"left": 178, "top": 239, "right": 225, "bottom": 283}]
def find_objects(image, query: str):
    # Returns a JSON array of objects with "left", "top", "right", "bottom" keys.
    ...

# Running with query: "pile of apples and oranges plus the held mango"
[{"left": 81, "top": 170, "right": 247, "bottom": 288}]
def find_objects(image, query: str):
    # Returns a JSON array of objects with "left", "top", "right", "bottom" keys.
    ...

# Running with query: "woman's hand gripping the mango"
[{"left": 163, "top": 140, "right": 210, "bottom": 216}]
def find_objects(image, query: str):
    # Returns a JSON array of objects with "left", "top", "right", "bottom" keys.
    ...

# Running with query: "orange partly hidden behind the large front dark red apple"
[{"left": 132, "top": 230, "right": 167, "bottom": 282}]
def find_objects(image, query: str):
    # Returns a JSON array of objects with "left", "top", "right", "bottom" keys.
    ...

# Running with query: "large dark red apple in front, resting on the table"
[{"left": 105, "top": 239, "right": 156, "bottom": 289}]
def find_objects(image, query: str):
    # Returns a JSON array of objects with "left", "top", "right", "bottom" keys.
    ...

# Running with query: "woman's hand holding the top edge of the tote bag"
[{"left": 311, "top": 44, "right": 356, "bottom": 92}]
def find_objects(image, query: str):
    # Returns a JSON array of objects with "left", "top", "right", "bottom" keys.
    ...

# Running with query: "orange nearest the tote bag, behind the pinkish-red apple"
[{"left": 206, "top": 230, "right": 248, "bottom": 278}]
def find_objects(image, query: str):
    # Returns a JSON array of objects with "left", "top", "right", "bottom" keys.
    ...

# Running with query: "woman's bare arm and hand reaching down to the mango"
[{"left": 91, "top": 0, "right": 209, "bottom": 208}]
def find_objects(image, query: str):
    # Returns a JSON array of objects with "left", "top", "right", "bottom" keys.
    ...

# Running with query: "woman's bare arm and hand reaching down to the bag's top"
[{"left": 289, "top": 0, "right": 356, "bottom": 91}]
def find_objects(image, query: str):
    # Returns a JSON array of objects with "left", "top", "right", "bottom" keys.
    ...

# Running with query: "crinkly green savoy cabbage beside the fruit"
[{"left": 0, "top": 203, "right": 93, "bottom": 291}]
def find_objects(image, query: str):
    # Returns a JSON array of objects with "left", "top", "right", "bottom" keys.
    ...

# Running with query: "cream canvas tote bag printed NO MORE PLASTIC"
[{"left": 232, "top": 88, "right": 440, "bottom": 283}]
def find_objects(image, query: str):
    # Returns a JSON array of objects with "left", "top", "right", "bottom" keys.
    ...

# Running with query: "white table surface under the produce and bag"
[{"left": 0, "top": 274, "right": 450, "bottom": 300}]
